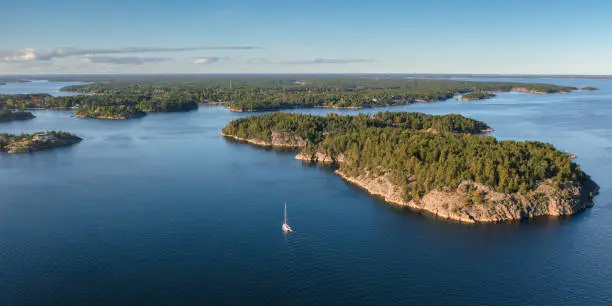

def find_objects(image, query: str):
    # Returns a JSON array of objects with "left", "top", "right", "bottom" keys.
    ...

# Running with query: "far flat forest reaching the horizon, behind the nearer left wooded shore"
[{"left": 56, "top": 76, "right": 576, "bottom": 111}]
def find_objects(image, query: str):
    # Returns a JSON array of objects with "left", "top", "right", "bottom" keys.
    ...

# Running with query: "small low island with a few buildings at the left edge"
[{"left": 0, "top": 131, "right": 82, "bottom": 154}]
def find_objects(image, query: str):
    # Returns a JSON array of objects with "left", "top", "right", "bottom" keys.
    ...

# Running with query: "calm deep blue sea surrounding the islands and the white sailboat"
[{"left": 0, "top": 79, "right": 612, "bottom": 305}]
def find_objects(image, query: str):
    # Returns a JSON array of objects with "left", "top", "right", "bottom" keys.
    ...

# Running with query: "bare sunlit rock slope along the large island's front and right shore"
[{"left": 295, "top": 152, "right": 599, "bottom": 223}]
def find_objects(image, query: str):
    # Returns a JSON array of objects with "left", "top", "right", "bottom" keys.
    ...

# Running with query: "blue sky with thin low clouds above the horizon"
[{"left": 0, "top": 0, "right": 612, "bottom": 75}]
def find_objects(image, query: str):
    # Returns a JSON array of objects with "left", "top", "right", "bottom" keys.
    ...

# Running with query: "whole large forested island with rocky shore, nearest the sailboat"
[{"left": 221, "top": 113, "right": 599, "bottom": 223}]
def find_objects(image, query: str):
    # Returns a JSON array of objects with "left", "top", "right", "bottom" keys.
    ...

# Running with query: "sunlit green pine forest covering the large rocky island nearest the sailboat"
[{"left": 223, "top": 113, "right": 586, "bottom": 200}]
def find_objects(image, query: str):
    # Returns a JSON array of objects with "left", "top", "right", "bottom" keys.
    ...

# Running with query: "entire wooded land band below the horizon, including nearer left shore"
[{"left": 0, "top": 76, "right": 577, "bottom": 119}]
